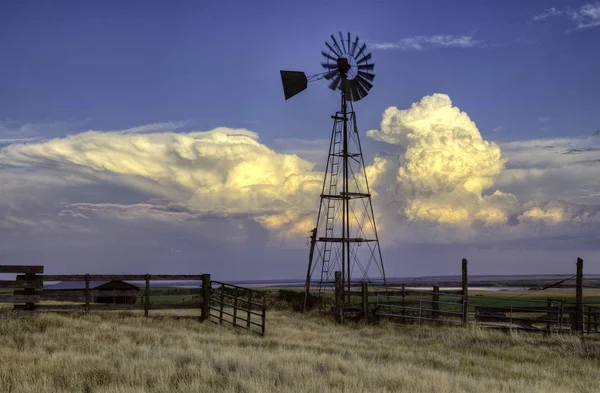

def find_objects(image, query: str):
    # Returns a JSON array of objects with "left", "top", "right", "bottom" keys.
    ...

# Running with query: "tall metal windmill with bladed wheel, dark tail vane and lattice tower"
[{"left": 281, "top": 32, "right": 385, "bottom": 300}]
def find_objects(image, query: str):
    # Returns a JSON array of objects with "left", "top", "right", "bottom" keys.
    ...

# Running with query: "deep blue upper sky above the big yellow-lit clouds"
[{"left": 0, "top": 1, "right": 600, "bottom": 141}]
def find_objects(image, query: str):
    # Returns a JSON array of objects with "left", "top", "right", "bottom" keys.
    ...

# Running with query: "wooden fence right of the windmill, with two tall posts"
[{"left": 334, "top": 258, "right": 600, "bottom": 334}]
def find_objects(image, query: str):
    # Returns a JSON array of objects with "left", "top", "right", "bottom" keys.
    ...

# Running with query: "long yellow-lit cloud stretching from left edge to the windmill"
[{"left": 0, "top": 128, "right": 322, "bottom": 240}]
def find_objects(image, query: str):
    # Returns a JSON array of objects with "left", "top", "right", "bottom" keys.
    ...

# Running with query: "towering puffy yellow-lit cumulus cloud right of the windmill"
[{"left": 367, "top": 94, "right": 510, "bottom": 224}]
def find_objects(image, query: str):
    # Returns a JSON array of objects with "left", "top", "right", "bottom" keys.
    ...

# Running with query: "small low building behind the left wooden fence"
[{"left": 44, "top": 280, "right": 140, "bottom": 304}]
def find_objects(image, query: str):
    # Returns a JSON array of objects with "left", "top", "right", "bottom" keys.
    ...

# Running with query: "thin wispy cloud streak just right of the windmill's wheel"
[{"left": 369, "top": 34, "right": 481, "bottom": 51}]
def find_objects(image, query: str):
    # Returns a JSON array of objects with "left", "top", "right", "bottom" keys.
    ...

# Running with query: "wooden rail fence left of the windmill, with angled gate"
[{"left": 0, "top": 265, "right": 266, "bottom": 335}]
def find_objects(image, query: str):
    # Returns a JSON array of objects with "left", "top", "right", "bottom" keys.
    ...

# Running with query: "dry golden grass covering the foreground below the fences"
[{"left": 0, "top": 312, "right": 600, "bottom": 393}]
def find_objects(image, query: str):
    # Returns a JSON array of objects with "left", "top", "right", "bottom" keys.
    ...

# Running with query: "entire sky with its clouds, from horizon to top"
[{"left": 0, "top": 0, "right": 600, "bottom": 280}]
